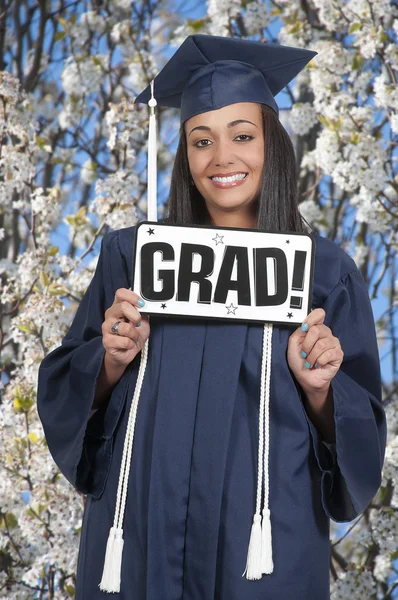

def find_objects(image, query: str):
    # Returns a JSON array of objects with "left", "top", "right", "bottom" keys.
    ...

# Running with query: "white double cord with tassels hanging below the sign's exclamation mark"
[{"left": 242, "top": 323, "right": 273, "bottom": 579}]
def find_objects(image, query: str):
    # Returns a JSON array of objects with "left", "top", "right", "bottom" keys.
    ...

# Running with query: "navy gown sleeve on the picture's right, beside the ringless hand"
[{"left": 304, "top": 270, "right": 387, "bottom": 522}]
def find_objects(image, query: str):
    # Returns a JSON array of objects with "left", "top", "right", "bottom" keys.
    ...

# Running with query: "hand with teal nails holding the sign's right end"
[{"left": 287, "top": 308, "right": 344, "bottom": 392}]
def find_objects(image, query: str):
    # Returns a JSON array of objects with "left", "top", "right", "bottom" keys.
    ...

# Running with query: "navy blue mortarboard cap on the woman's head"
[{"left": 135, "top": 34, "right": 317, "bottom": 123}]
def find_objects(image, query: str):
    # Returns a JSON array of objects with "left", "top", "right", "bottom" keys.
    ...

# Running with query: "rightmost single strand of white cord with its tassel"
[{"left": 261, "top": 324, "right": 274, "bottom": 575}]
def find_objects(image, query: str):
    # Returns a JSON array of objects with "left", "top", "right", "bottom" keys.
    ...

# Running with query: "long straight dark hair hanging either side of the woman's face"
[{"left": 164, "top": 104, "right": 306, "bottom": 232}]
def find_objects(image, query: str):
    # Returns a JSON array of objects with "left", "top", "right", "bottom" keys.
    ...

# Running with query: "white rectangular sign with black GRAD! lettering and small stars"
[{"left": 131, "top": 221, "right": 315, "bottom": 325}]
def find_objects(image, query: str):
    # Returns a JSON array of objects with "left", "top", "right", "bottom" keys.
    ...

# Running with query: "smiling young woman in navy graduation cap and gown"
[{"left": 38, "top": 36, "right": 386, "bottom": 600}]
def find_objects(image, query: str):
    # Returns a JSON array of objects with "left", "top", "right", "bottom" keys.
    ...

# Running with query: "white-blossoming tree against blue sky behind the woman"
[{"left": 0, "top": 0, "right": 398, "bottom": 600}]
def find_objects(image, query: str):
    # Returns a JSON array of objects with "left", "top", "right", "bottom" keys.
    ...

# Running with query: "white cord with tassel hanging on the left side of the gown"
[{"left": 99, "top": 338, "right": 149, "bottom": 593}]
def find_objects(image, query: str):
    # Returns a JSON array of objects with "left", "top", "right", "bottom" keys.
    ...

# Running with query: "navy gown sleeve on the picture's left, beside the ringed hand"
[{"left": 37, "top": 231, "right": 134, "bottom": 498}]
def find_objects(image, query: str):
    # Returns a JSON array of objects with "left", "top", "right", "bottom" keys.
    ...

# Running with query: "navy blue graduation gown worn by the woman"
[{"left": 38, "top": 227, "right": 386, "bottom": 600}]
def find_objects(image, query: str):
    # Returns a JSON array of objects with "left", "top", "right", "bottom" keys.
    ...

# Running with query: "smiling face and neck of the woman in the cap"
[{"left": 185, "top": 102, "right": 264, "bottom": 228}]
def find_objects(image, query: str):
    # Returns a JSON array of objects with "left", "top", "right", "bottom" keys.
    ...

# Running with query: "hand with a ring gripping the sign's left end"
[{"left": 102, "top": 288, "right": 150, "bottom": 368}]
